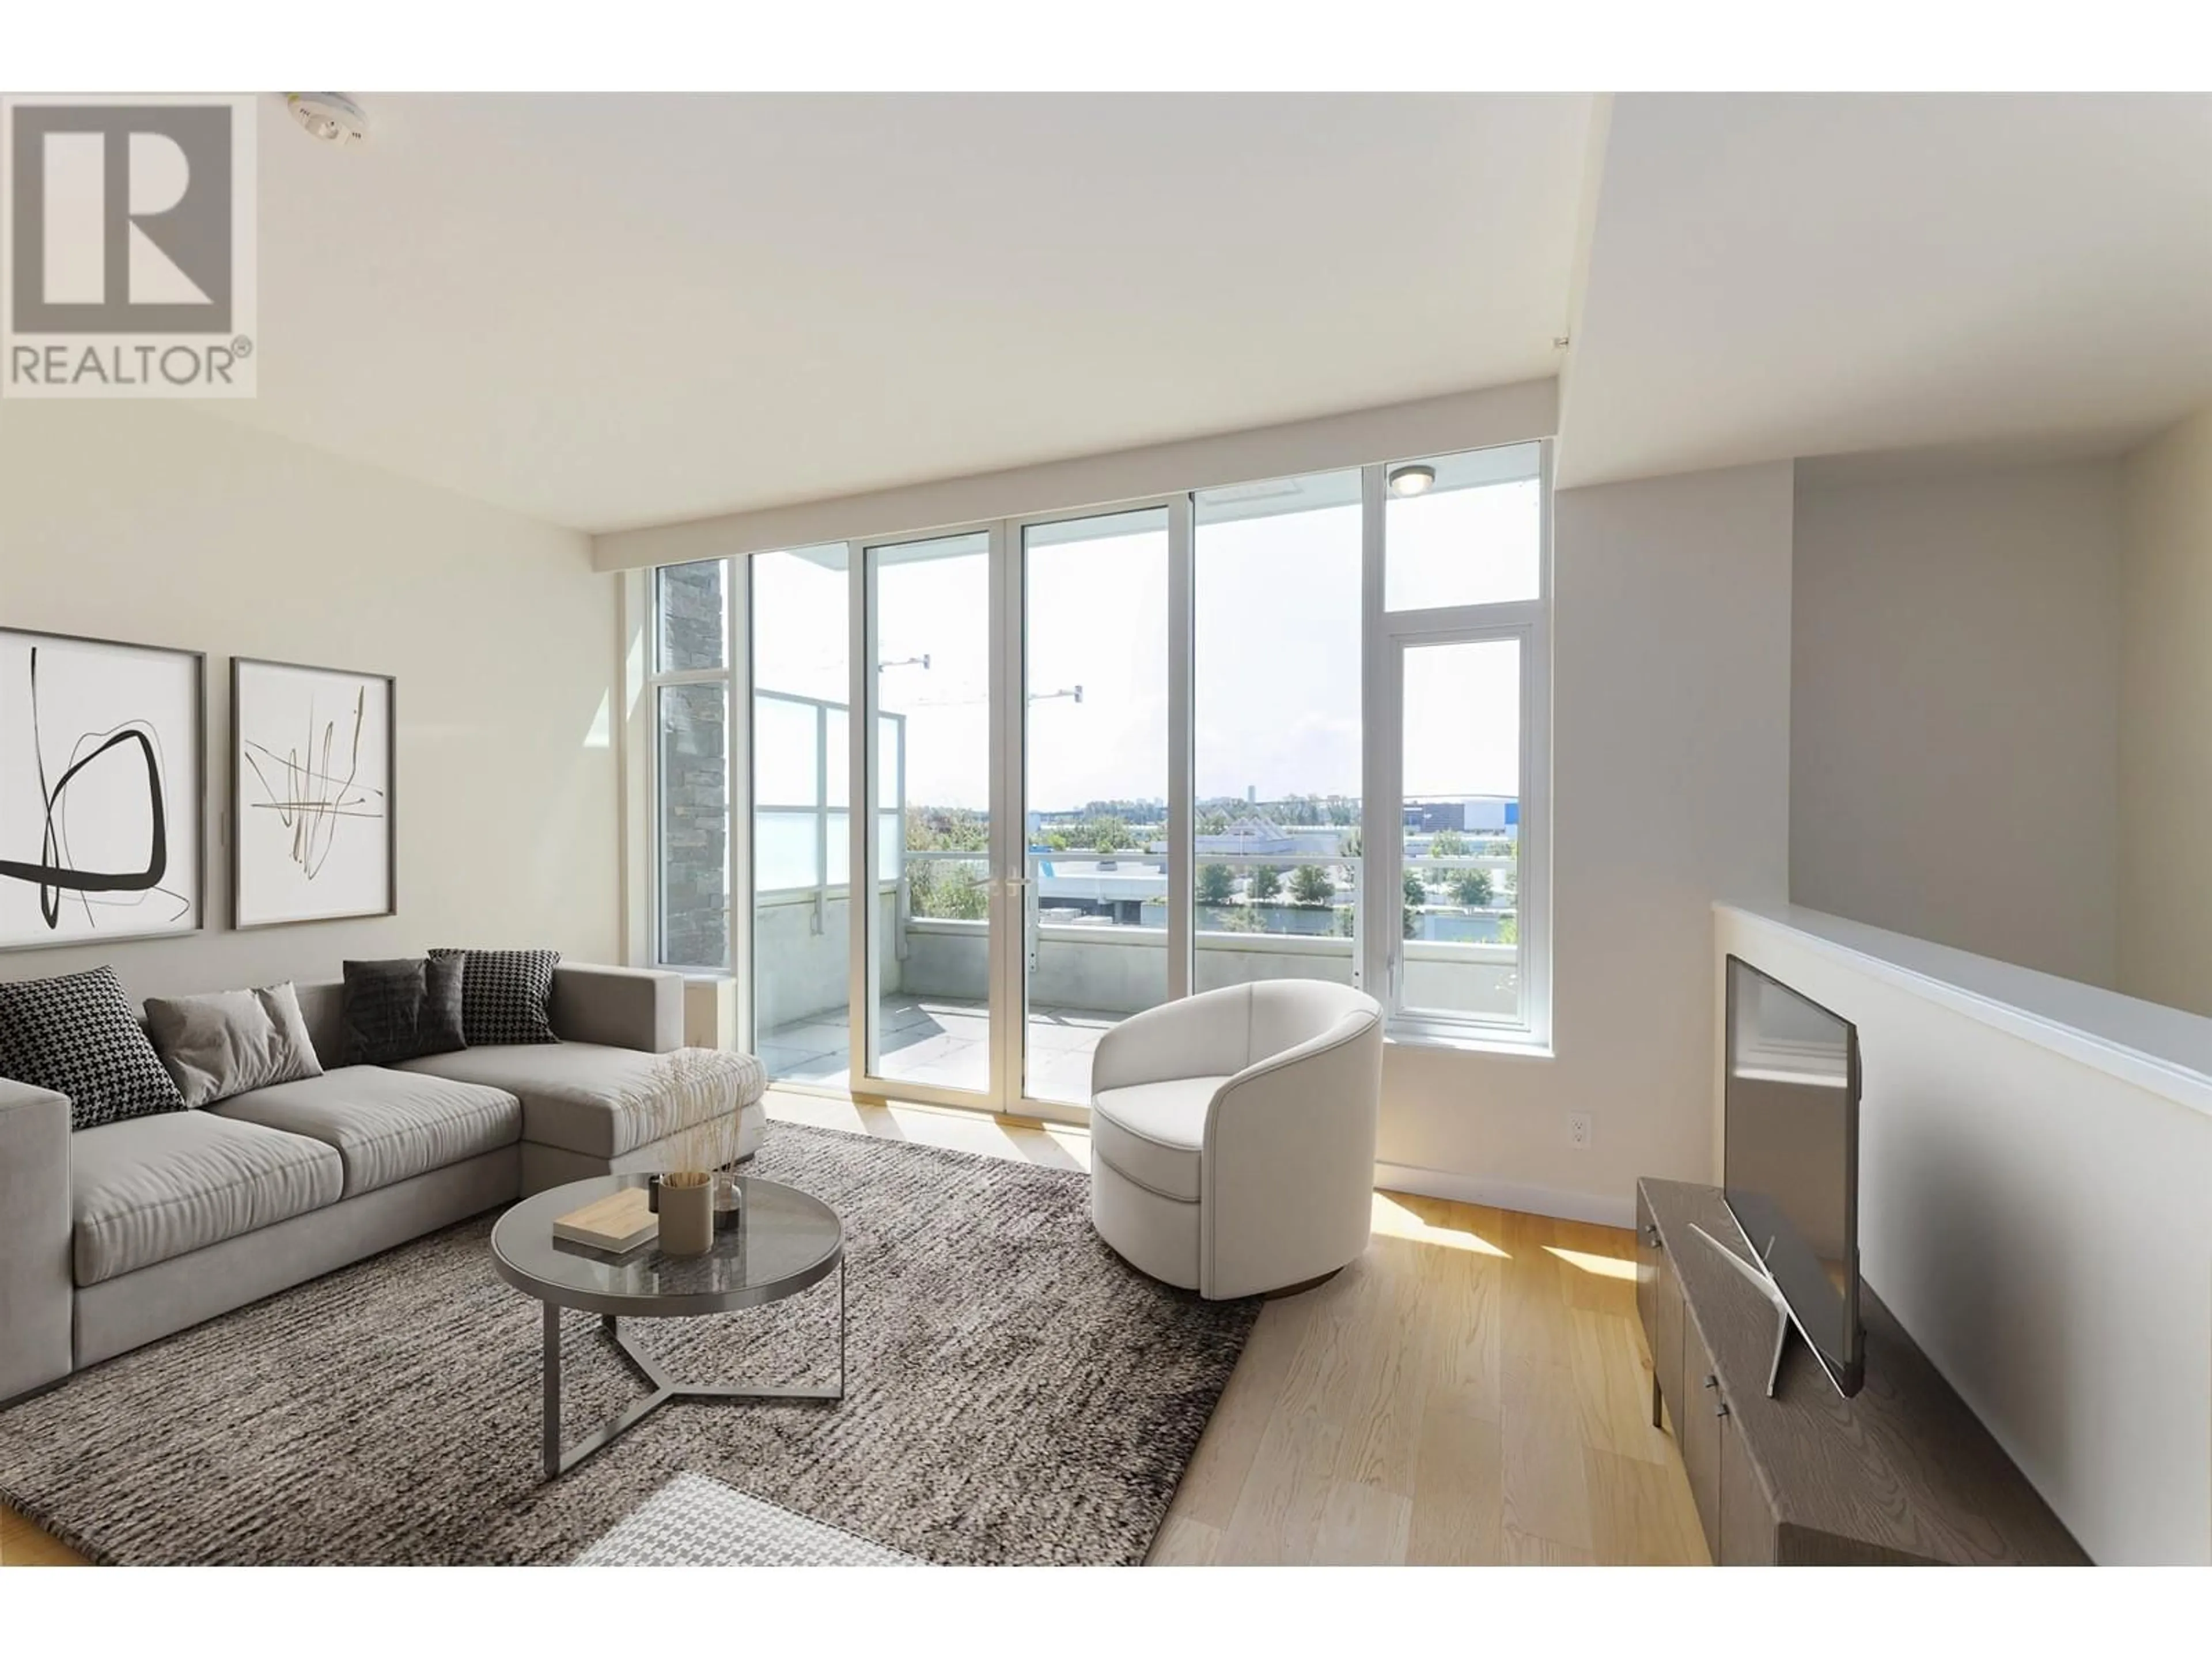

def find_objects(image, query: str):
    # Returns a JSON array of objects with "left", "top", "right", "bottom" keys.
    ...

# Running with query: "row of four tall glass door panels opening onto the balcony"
[{"left": 750, "top": 493, "right": 1365, "bottom": 1117}]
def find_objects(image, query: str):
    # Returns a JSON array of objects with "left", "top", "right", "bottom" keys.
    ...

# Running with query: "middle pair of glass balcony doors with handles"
[{"left": 831, "top": 513, "right": 1190, "bottom": 1115}]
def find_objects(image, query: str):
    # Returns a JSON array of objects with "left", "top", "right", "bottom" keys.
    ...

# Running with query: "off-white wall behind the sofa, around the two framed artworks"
[{"left": 0, "top": 403, "right": 619, "bottom": 995}]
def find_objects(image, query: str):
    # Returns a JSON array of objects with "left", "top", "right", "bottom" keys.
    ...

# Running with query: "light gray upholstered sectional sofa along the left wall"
[{"left": 0, "top": 964, "right": 763, "bottom": 1403}]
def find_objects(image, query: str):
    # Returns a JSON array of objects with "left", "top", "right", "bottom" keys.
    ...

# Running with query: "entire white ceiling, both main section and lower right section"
[{"left": 201, "top": 93, "right": 2212, "bottom": 531}]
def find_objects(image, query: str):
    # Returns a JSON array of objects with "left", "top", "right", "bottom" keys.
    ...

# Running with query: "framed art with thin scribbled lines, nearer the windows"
[{"left": 230, "top": 657, "right": 398, "bottom": 927}]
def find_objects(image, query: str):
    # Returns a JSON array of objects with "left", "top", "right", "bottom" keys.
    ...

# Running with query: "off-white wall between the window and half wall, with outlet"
[{"left": 1380, "top": 463, "right": 1791, "bottom": 1225}]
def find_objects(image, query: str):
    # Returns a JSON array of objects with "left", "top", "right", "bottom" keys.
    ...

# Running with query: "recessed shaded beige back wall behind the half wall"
[{"left": 1790, "top": 460, "right": 2122, "bottom": 984}]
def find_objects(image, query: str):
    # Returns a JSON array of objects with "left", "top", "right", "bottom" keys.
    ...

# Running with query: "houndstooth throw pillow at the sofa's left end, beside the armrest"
[{"left": 0, "top": 967, "right": 184, "bottom": 1128}]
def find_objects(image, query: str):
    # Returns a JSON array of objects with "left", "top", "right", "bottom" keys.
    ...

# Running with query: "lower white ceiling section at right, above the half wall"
[{"left": 1557, "top": 93, "right": 2212, "bottom": 484}]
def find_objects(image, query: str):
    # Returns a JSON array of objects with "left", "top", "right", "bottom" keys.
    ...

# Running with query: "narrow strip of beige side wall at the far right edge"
[{"left": 2119, "top": 409, "right": 2212, "bottom": 1013}]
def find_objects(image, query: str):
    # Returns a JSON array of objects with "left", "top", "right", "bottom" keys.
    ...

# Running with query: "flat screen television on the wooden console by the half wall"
[{"left": 1723, "top": 956, "right": 1865, "bottom": 1393}]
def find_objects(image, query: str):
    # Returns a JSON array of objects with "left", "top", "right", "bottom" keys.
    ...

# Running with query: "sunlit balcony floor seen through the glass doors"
[{"left": 761, "top": 993, "right": 1124, "bottom": 1106}]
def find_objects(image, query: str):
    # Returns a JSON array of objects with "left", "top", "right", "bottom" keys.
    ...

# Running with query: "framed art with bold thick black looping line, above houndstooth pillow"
[{"left": 0, "top": 628, "right": 206, "bottom": 949}]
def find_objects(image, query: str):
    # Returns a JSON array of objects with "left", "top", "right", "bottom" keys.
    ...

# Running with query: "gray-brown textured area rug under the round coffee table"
[{"left": 0, "top": 1124, "right": 1259, "bottom": 1564}]
